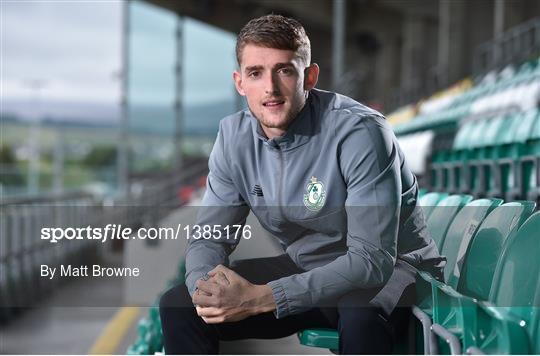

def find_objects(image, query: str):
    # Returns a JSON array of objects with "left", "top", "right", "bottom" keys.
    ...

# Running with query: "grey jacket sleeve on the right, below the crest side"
[{"left": 268, "top": 117, "right": 401, "bottom": 318}]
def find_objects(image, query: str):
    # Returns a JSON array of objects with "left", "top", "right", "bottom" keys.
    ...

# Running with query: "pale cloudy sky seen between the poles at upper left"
[{"left": 0, "top": 0, "right": 235, "bottom": 121}]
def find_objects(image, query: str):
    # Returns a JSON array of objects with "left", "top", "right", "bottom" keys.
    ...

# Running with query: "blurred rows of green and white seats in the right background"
[{"left": 430, "top": 108, "right": 540, "bottom": 200}]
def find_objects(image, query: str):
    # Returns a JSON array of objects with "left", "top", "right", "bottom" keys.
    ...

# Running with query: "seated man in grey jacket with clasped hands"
[{"left": 160, "top": 15, "right": 444, "bottom": 354}]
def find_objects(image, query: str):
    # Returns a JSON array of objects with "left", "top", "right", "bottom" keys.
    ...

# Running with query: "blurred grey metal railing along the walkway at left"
[{"left": 0, "top": 162, "right": 207, "bottom": 321}]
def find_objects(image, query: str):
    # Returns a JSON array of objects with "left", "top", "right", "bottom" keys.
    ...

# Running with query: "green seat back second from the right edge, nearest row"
[{"left": 457, "top": 201, "right": 536, "bottom": 300}]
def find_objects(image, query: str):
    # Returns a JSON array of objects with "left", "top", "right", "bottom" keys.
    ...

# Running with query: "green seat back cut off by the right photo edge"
[{"left": 489, "top": 212, "right": 540, "bottom": 324}]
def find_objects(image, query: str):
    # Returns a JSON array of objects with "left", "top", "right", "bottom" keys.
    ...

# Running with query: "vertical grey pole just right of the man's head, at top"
[{"left": 332, "top": 0, "right": 347, "bottom": 90}]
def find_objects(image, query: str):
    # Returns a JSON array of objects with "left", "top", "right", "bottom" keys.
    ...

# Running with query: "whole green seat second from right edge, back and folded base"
[{"left": 432, "top": 201, "right": 536, "bottom": 349}]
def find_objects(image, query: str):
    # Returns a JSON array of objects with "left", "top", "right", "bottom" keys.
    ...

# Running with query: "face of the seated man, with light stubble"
[{"left": 234, "top": 44, "right": 318, "bottom": 138}]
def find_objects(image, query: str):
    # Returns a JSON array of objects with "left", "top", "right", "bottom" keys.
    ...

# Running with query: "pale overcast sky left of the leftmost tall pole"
[{"left": 0, "top": 0, "right": 121, "bottom": 103}]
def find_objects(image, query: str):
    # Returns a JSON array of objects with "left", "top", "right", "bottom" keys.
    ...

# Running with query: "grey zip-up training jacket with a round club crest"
[{"left": 186, "top": 89, "right": 444, "bottom": 318}]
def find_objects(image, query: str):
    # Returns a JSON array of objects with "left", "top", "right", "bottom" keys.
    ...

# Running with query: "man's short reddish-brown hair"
[{"left": 236, "top": 15, "right": 311, "bottom": 66}]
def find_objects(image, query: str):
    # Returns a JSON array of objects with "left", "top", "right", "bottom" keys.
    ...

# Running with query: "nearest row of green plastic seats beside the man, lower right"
[{"left": 413, "top": 193, "right": 540, "bottom": 354}]
